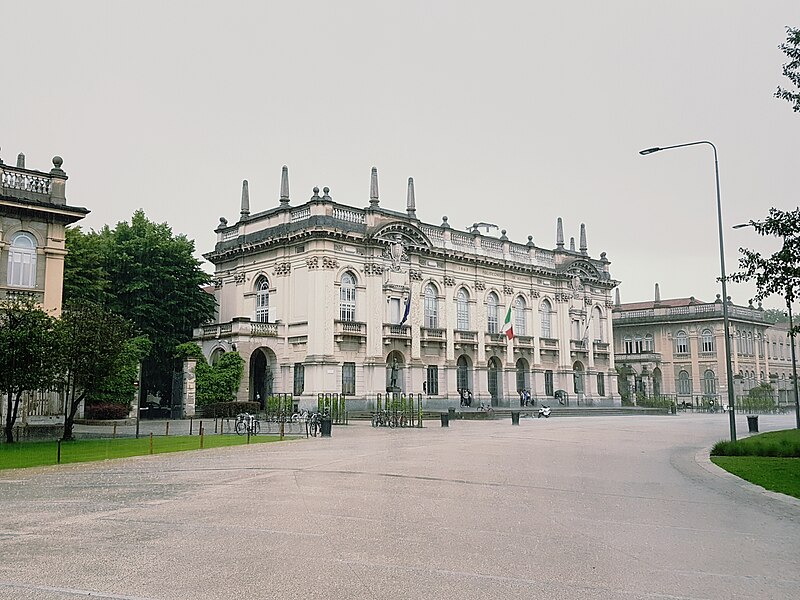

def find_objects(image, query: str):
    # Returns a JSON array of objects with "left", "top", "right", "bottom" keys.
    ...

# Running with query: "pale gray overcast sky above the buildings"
[{"left": 0, "top": 0, "right": 800, "bottom": 307}]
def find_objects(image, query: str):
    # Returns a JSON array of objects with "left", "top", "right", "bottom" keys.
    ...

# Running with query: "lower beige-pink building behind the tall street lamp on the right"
[{"left": 612, "top": 284, "right": 794, "bottom": 404}]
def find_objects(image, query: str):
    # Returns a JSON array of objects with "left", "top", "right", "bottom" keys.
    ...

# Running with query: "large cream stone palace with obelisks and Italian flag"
[{"left": 195, "top": 167, "right": 619, "bottom": 407}]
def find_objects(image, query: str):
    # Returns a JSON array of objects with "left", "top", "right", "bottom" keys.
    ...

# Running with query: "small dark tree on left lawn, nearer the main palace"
[{"left": 56, "top": 302, "right": 133, "bottom": 440}]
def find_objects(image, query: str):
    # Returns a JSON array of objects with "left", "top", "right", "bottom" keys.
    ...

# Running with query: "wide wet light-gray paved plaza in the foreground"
[{"left": 0, "top": 414, "right": 800, "bottom": 600}]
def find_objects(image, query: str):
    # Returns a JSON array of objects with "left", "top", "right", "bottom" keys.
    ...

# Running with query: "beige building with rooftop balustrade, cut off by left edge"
[{"left": 0, "top": 154, "right": 89, "bottom": 416}]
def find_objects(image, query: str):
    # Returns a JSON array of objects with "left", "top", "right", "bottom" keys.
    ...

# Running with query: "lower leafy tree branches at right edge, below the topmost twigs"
[{"left": 730, "top": 208, "right": 800, "bottom": 335}]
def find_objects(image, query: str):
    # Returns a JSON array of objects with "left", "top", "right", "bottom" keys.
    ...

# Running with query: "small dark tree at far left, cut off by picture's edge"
[{"left": 0, "top": 299, "right": 58, "bottom": 443}]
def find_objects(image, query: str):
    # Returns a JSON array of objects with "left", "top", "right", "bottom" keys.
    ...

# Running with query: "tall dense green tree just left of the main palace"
[{"left": 65, "top": 210, "right": 215, "bottom": 398}]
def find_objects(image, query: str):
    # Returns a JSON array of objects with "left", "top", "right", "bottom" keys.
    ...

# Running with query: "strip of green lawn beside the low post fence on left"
[{"left": 0, "top": 435, "right": 287, "bottom": 469}]
